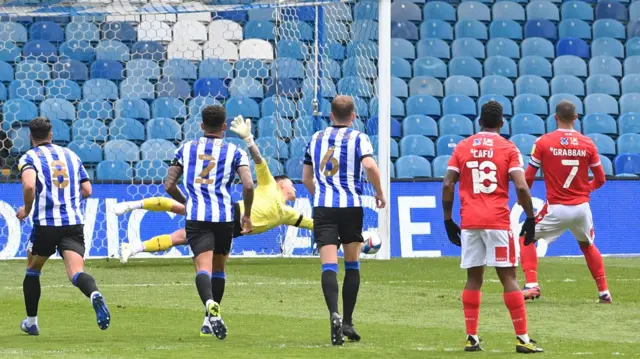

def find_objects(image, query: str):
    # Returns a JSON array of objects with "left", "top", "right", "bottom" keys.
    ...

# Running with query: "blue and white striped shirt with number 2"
[{"left": 175, "top": 137, "right": 249, "bottom": 222}]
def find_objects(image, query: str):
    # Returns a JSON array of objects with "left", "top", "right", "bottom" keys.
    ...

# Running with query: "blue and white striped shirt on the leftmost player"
[{"left": 18, "top": 144, "right": 89, "bottom": 227}]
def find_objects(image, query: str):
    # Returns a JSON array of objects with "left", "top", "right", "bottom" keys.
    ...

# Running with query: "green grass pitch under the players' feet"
[{"left": 0, "top": 258, "right": 640, "bottom": 359}]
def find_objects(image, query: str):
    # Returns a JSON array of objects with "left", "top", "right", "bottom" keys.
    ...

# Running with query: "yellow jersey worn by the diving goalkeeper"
[{"left": 238, "top": 160, "right": 313, "bottom": 234}]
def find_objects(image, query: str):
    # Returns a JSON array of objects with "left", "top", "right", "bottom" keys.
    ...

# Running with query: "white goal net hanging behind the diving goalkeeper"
[{"left": 0, "top": 0, "right": 389, "bottom": 258}]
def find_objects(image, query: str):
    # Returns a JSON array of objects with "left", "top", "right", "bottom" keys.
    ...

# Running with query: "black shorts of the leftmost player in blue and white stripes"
[{"left": 29, "top": 224, "right": 84, "bottom": 257}]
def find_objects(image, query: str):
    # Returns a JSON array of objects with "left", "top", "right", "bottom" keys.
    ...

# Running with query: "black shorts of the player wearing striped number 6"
[{"left": 313, "top": 207, "right": 364, "bottom": 248}]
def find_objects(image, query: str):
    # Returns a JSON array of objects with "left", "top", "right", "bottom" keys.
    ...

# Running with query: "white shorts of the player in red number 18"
[{"left": 460, "top": 229, "right": 518, "bottom": 269}]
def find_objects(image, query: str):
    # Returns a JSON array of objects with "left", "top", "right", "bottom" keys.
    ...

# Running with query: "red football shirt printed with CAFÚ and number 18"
[{"left": 447, "top": 132, "right": 524, "bottom": 230}]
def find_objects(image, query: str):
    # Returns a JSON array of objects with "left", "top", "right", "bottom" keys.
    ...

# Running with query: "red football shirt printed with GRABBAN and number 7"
[{"left": 529, "top": 129, "right": 600, "bottom": 205}]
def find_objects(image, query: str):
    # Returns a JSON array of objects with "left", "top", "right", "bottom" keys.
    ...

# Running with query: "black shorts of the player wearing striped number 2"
[{"left": 185, "top": 221, "right": 234, "bottom": 256}]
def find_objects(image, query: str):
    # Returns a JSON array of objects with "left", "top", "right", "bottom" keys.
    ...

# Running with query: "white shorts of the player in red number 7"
[{"left": 536, "top": 202, "right": 595, "bottom": 243}]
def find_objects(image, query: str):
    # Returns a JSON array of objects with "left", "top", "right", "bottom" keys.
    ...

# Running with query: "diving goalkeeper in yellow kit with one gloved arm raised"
[{"left": 114, "top": 116, "right": 313, "bottom": 263}]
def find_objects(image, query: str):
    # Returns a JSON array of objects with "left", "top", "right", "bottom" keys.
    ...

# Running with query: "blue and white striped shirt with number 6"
[{"left": 304, "top": 126, "right": 373, "bottom": 208}]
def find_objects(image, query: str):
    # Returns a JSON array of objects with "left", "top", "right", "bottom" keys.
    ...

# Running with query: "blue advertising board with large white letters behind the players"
[{"left": 0, "top": 180, "right": 640, "bottom": 259}]
